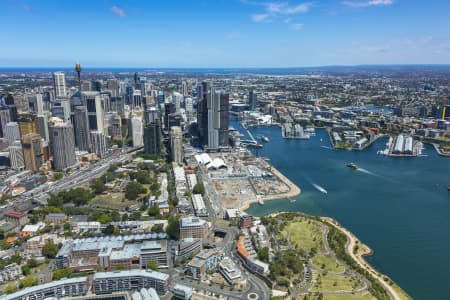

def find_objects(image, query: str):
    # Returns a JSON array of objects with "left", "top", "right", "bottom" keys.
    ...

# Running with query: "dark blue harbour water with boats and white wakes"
[{"left": 239, "top": 121, "right": 450, "bottom": 299}]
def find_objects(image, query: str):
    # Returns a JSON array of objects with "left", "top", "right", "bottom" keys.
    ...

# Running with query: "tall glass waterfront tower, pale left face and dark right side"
[{"left": 207, "top": 88, "right": 229, "bottom": 150}]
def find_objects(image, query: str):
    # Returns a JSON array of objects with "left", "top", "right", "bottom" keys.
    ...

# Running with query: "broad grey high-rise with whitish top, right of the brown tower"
[{"left": 49, "top": 118, "right": 77, "bottom": 170}]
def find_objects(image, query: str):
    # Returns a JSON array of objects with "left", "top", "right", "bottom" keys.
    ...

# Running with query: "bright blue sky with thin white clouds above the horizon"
[{"left": 0, "top": 0, "right": 450, "bottom": 67}]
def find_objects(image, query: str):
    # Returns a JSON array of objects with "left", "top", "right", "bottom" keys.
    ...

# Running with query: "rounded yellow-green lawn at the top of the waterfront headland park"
[{"left": 283, "top": 220, "right": 324, "bottom": 252}]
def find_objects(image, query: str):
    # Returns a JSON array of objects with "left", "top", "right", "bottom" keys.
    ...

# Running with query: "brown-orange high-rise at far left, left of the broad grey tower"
[{"left": 22, "top": 132, "right": 44, "bottom": 171}]
